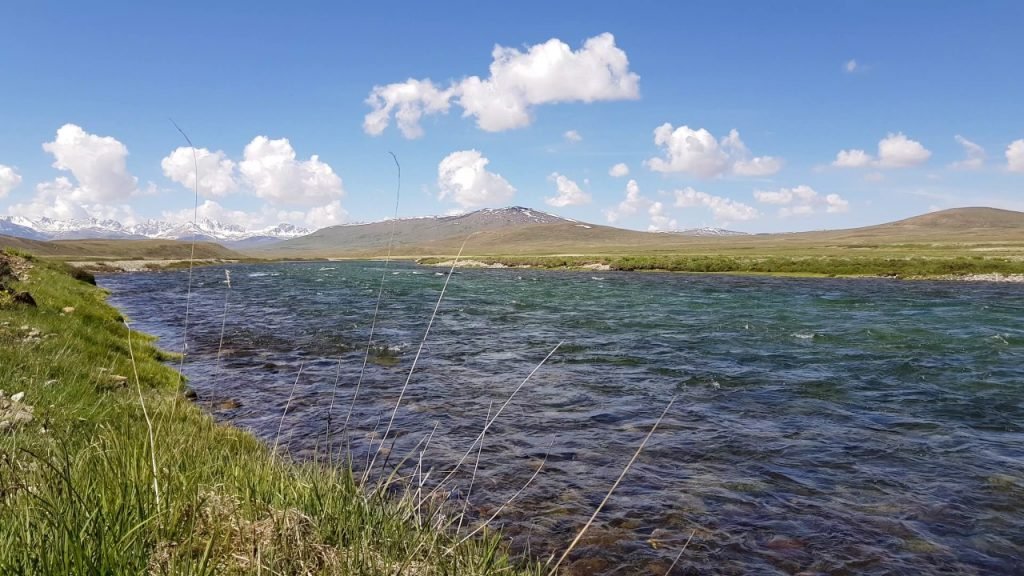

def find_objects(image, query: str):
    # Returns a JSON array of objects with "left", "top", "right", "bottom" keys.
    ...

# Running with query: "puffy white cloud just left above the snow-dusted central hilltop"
[{"left": 437, "top": 150, "right": 516, "bottom": 208}]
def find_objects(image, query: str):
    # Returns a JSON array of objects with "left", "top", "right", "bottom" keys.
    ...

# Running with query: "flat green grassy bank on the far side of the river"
[{"left": 418, "top": 254, "right": 1024, "bottom": 278}]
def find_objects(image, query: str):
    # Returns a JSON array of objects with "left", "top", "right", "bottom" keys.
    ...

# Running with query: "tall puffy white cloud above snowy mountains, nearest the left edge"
[{"left": 43, "top": 124, "right": 137, "bottom": 203}]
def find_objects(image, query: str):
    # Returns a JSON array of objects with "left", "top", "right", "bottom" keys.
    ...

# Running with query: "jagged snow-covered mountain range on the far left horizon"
[{"left": 0, "top": 216, "right": 311, "bottom": 244}]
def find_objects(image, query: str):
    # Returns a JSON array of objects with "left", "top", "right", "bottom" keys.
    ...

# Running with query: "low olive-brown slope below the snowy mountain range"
[{"left": 0, "top": 236, "right": 245, "bottom": 260}]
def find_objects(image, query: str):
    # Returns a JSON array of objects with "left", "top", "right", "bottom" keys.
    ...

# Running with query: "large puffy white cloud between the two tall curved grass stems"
[{"left": 239, "top": 136, "right": 345, "bottom": 206}]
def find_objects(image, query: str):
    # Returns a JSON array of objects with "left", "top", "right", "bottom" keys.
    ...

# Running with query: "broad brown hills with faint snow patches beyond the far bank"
[{"left": 249, "top": 202, "right": 1024, "bottom": 257}]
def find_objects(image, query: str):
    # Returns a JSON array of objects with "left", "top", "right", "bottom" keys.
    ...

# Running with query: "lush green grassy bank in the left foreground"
[{"left": 0, "top": 251, "right": 540, "bottom": 575}]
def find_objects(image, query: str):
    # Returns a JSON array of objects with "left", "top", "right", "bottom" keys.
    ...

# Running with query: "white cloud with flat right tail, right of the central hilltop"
[{"left": 646, "top": 122, "right": 782, "bottom": 178}]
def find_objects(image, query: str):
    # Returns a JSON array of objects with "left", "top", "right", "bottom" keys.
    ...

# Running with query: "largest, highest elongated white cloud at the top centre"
[{"left": 364, "top": 33, "right": 640, "bottom": 138}]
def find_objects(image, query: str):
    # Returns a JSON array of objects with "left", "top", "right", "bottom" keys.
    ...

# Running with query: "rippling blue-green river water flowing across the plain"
[{"left": 100, "top": 262, "right": 1024, "bottom": 574}]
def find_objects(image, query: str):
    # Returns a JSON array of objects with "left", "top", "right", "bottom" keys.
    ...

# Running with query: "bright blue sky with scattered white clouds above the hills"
[{"left": 0, "top": 0, "right": 1024, "bottom": 232}]
